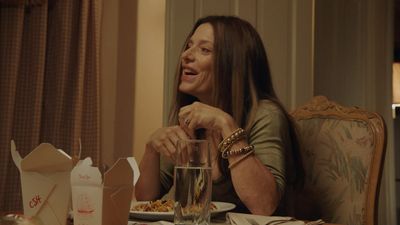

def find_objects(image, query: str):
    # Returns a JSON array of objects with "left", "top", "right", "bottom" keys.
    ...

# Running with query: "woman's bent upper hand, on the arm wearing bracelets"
[{"left": 178, "top": 102, "right": 233, "bottom": 131}]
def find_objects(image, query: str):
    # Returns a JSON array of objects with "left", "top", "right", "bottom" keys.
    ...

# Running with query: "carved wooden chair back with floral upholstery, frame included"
[{"left": 291, "top": 96, "right": 386, "bottom": 225}]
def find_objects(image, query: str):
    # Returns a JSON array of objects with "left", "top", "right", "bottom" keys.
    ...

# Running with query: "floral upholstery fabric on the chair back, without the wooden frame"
[{"left": 297, "top": 117, "right": 374, "bottom": 225}]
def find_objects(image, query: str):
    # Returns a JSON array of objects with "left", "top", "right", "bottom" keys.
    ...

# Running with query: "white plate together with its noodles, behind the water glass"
[{"left": 130, "top": 200, "right": 236, "bottom": 221}]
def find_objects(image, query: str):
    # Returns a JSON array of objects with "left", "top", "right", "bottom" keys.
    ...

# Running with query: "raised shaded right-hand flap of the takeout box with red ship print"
[{"left": 104, "top": 158, "right": 133, "bottom": 186}]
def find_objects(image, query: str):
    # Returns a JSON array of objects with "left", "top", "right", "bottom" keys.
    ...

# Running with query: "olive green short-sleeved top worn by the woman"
[{"left": 160, "top": 100, "right": 290, "bottom": 212}]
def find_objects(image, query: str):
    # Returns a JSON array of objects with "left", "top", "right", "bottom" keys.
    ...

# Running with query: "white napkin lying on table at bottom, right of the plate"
[{"left": 226, "top": 212, "right": 324, "bottom": 225}]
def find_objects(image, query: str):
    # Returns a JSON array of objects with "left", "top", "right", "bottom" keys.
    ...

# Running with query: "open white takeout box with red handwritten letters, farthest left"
[{"left": 11, "top": 141, "right": 72, "bottom": 225}]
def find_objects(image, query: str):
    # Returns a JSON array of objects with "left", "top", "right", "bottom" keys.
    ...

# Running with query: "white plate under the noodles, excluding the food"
[{"left": 129, "top": 202, "right": 236, "bottom": 221}]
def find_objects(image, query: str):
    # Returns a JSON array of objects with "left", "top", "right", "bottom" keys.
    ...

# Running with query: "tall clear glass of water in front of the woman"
[{"left": 174, "top": 139, "right": 212, "bottom": 225}]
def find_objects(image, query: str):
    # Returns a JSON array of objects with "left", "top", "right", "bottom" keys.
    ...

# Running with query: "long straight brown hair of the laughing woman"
[{"left": 169, "top": 16, "right": 304, "bottom": 186}]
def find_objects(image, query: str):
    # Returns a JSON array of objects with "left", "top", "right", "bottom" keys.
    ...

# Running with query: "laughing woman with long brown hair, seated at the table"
[{"left": 135, "top": 16, "right": 302, "bottom": 215}]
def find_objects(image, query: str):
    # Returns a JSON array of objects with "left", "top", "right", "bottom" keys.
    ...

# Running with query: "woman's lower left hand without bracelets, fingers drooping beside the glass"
[{"left": 146, "top": 126, "right": 190, "bottom": 163}]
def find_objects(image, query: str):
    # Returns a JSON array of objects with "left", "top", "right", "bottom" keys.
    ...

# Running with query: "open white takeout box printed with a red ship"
[{"left": 71, "top": 157, "right": 139, "bottom": 225}]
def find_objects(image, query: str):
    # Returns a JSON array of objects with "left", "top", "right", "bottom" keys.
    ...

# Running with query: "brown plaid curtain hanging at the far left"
[{"left": 0, "top": 0, "right": 102, "bottom": 212}]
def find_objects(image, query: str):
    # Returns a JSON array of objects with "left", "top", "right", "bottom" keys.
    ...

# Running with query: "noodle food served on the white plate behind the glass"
[{"left": 131, "top": 199, "right": 217, "bottom": 212}]
